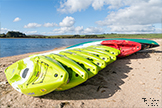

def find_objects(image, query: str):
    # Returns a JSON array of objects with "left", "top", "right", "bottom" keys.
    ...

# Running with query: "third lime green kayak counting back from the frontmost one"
[{"left": 59, "top": 51, "right": 99, "bottom": 78}]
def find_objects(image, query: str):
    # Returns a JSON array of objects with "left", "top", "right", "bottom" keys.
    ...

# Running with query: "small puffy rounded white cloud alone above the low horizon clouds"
[{"left": 59, "top": 16, "right": 75, "bottom": 27}]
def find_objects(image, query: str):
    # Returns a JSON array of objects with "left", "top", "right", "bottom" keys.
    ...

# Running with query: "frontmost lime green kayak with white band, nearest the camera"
[{"left": 5, "top": 56, "right": 69, "bottom": 96}]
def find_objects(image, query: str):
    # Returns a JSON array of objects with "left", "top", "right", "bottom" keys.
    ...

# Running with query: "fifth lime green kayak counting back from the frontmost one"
[{"left": 78, "top": 48, "right": 111, "bottom": 64}]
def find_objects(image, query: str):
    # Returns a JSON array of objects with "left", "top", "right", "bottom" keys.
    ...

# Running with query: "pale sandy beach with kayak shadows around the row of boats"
[{"left": 0, "top": 39, "right": 162, "bottom": 108}]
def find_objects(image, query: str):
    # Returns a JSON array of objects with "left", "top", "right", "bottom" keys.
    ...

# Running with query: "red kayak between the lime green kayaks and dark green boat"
[{"left": 101, "top": 40, "right": 141, "bottom": 57}]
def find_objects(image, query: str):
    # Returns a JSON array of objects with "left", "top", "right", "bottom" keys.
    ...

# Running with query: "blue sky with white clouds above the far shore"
[{"left": 0, "top": 0, "right": 162, "bottom": 35}]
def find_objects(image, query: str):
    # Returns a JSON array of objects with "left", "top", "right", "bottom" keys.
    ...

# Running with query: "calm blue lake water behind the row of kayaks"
[{"left": 0, "top": 39, "right": 97, "bottom": 57}]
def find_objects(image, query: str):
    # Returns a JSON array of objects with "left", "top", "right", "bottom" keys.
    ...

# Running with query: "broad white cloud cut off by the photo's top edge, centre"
[{"left": 57, "top": 0, "right": 135, "bottom": 13}]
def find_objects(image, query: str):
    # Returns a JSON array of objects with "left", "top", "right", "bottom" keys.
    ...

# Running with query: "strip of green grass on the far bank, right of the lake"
[{"left": 97, "top": 34, "right": 162, "bottom": 38}]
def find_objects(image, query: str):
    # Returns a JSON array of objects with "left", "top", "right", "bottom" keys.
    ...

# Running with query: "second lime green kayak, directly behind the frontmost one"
[{"left": 47, "top": 54, "right": 88, "bottom": 91}]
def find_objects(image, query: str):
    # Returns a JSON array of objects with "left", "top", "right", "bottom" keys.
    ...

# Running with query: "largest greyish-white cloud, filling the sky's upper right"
[{"left": 96, "top": 0, "right": 162, "bottom": 26}]
